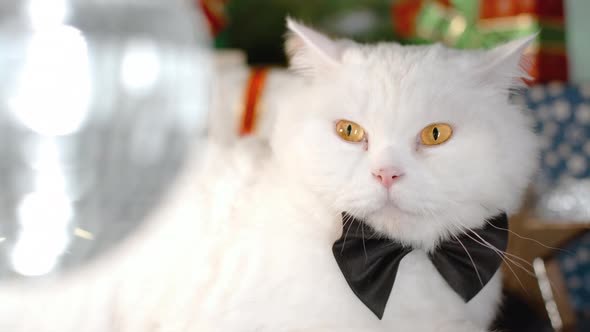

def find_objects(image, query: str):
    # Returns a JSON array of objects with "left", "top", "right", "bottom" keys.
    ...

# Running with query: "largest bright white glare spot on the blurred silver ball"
[{"left": 10, "top": 25, "right": 90, "bottom": 136}]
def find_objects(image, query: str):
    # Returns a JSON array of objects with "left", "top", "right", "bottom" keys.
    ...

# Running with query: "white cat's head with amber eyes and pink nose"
[{"left": 273, "top": 19, "right": 536, "bottom": 248}]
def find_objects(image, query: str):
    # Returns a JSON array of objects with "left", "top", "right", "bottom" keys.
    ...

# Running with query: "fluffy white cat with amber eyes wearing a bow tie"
[{"left": 0, "top": 21, "right": 536, "bottom": 332}]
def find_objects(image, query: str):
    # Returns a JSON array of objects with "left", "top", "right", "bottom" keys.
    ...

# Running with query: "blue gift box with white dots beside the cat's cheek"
[{"left": 515, "top": 83, "right": 590, "bottom": 223}]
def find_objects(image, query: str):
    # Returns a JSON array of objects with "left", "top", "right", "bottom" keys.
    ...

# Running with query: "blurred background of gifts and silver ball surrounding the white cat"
[{"left": 0, "top": 0, "right": 590, "bottom": 332}]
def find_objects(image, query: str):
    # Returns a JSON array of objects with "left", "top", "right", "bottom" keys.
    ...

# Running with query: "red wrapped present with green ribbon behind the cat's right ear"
[{"left": 392, "top": 0, "right": 568, "bottom": 82}]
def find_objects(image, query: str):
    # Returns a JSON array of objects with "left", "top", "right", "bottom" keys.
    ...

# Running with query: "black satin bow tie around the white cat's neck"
[{"left": 332, "top": 213, "right": 508, "bottom": 319}]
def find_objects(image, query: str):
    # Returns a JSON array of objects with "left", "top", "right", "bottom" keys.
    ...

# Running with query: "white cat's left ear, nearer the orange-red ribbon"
[{"left": 285, "top": 18, "right": 344, "bottom": 76}]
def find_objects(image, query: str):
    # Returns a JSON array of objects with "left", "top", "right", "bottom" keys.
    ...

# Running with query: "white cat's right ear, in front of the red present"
[{"left": 479, "top": 34, "right": 537, "bottom": 91}]
